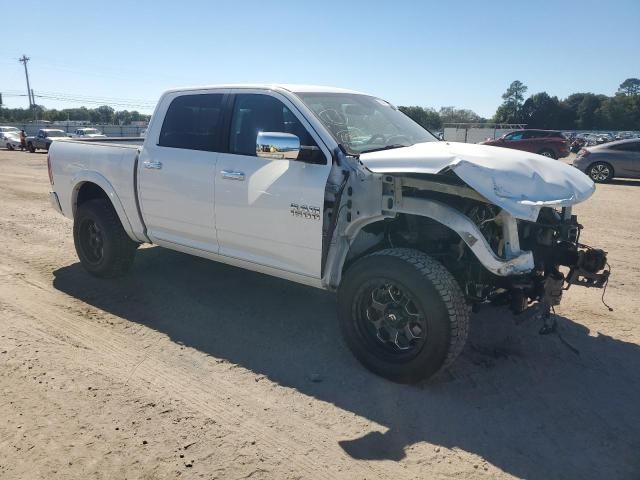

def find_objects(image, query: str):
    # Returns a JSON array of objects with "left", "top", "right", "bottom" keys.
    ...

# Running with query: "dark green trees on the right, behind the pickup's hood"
[{"left": 398, "top": 78, "right": 640, "bottom": 130}]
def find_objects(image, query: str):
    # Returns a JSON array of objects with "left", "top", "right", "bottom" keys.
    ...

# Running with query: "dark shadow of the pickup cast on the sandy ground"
[{"left": 54, "top": 247, "right": 640, "bottom": 479}]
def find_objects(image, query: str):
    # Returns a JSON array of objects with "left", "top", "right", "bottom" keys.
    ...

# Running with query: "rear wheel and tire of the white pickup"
[{"left": 73, "top": 198, "right": 138, "bottom": 278}]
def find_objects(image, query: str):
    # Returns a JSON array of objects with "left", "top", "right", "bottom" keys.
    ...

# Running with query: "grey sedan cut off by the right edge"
[{"left": 573, "top": 138, "right": 640, "bottom": 183}]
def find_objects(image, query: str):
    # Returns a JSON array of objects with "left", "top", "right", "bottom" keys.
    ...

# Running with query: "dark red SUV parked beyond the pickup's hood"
[{"left": 480, "top": 130, "right": 569, "bottom": 158}]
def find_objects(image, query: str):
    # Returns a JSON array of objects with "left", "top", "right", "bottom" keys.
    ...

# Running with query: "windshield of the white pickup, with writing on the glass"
[{"left": 297, "top": 93, "right": 438, "bottom": 155}]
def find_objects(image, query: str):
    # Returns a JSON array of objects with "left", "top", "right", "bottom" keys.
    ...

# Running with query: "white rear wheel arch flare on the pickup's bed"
[{"left": 71, "top": 172, "right": 141, "bottom": 242}]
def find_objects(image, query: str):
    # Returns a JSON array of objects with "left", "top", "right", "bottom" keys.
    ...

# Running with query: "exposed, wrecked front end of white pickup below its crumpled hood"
[{"left": 344, "top": 172, "right": 609, "bottom": 313}]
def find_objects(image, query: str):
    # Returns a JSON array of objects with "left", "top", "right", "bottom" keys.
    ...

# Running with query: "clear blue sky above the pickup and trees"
[{"left": 0, "top": 0, "right": 640, "bottom": 116}]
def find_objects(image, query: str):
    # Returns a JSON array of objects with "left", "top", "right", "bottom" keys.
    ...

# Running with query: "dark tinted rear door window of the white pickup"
[{"left": 158, "top": 93, "right": 223, "bottom": 152}]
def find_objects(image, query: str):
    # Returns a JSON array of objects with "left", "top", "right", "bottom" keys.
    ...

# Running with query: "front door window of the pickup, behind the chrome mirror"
[{"left": 229, "top": 93, "right": 325, "bottom": 163}]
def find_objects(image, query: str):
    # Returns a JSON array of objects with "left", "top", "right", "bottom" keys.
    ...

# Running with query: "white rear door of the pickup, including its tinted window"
[{"left": 138, "top": 90, "right": 228, "bottom": 253}]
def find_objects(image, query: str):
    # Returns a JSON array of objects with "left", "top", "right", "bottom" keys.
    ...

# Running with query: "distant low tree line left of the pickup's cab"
[{"left": 0, "top": 105, "right": 151, "bottom": 125}]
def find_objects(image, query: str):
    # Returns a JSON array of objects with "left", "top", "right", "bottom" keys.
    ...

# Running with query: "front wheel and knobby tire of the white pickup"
[{"left": 338, "top": 248, "right": 469, "bottom": 383}]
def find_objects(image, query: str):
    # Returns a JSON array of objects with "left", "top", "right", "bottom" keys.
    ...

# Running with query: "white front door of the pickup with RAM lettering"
[{"left": 215, "top": 89, "right": 331, "bottom": 278}]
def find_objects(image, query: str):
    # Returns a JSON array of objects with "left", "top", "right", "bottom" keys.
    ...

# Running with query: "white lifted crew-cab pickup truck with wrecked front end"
[{"left": 48, "top": 85, "right": 609, "bottom": 383}]
